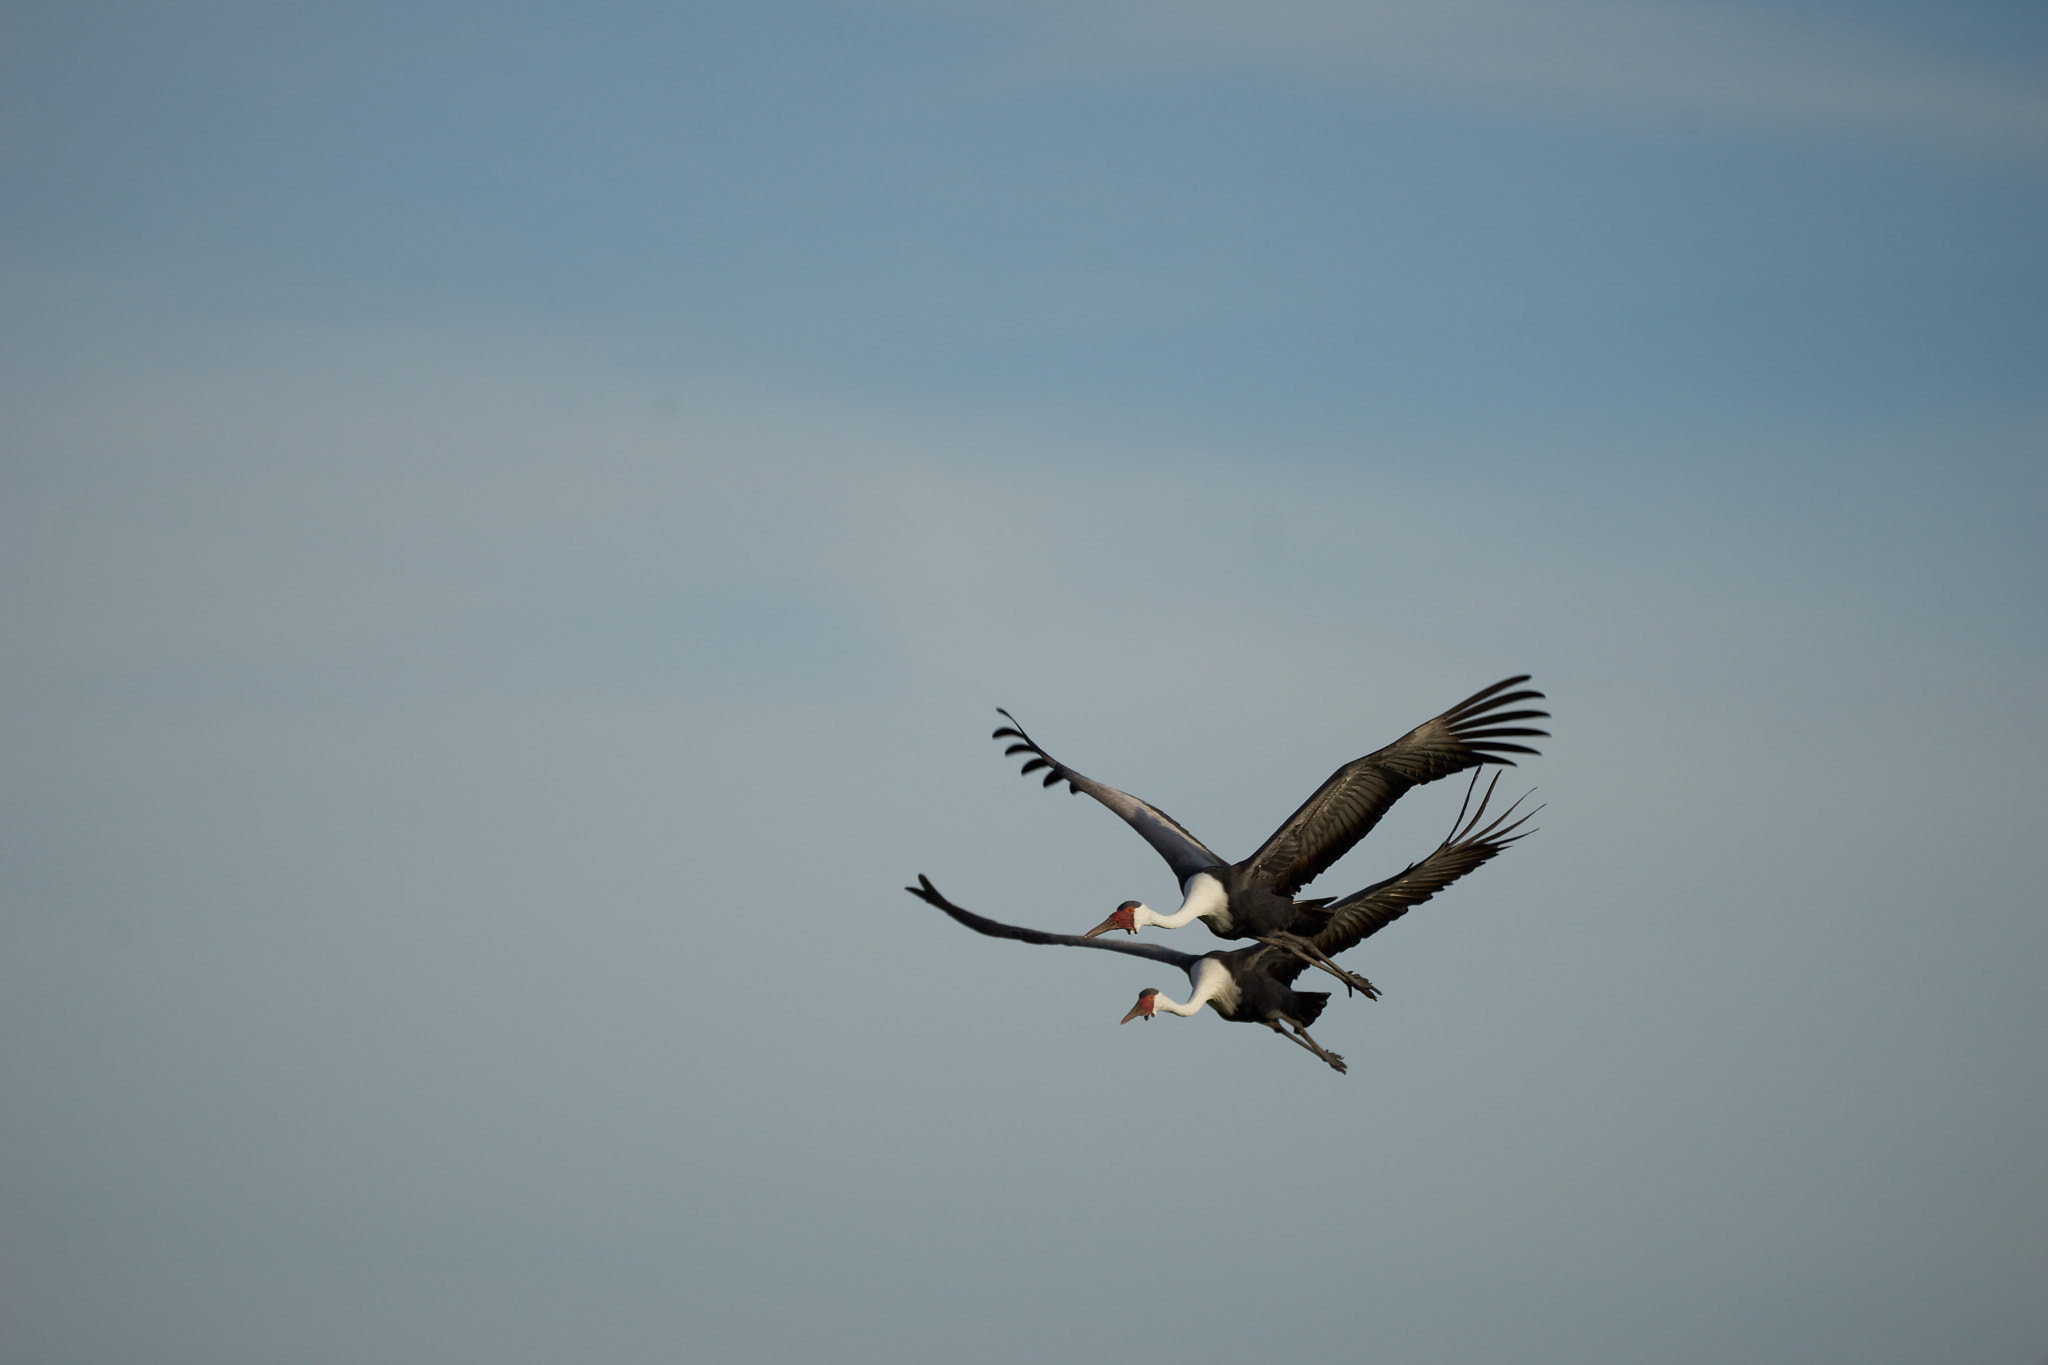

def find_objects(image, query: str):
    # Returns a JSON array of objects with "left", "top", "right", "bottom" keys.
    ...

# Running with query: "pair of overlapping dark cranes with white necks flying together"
[{"left": 905, "top": 673, "right": 1550, "bottom": 1072}]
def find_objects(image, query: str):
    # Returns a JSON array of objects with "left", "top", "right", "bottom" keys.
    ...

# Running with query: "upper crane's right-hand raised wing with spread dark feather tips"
[{"left": 1239, "top": 673, "right": 1550, "bottom": 896}]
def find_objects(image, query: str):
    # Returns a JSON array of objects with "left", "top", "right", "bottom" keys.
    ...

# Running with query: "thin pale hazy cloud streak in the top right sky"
[{"left": 888, "top": 0, "right": 2048, "bottom": 153}]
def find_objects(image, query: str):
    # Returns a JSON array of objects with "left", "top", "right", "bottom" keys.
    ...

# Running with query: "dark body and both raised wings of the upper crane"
[{"left": 993, "top": 673, "right": 1550, "bottom": 939}]
